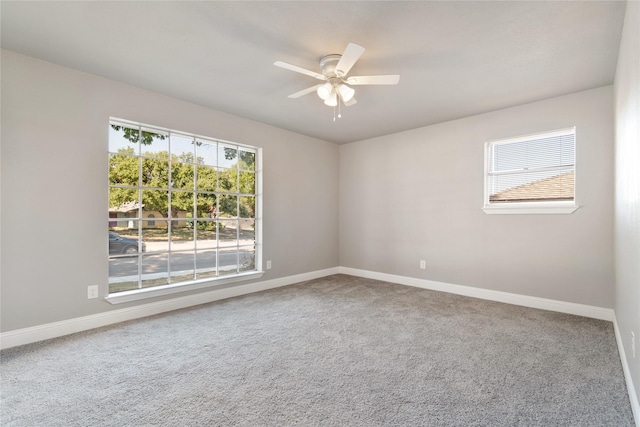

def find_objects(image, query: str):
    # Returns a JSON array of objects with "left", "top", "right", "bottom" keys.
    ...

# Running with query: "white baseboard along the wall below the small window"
[{"left": 338, "top": 267, "right": 614, "bottom": 322}]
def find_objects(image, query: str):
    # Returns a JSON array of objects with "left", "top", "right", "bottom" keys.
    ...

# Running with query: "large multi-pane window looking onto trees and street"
[{"left": 108, "top": 120, "right": 260, "bottom": 296}]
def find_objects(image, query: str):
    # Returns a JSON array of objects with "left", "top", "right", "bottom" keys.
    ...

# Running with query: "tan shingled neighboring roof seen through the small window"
[{"left": 489, "top": 171, "right": 575, "bottom": 202}]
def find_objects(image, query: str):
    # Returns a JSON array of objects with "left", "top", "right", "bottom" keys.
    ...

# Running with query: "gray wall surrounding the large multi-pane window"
[{"left": 1, "top": 51, "right": 339, "bottom": 331}]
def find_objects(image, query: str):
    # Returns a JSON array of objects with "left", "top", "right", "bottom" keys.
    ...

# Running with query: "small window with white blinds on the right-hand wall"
[{"left": 484, "top": 128, "right": 578, "bottom": 214}]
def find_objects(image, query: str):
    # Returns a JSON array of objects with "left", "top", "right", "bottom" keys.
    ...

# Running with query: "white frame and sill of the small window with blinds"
[{"left": 482, "top": 127, "right": 580, "bottom": 215}]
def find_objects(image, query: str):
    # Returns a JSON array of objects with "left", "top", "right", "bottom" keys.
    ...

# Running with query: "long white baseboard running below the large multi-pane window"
[{"left": 0, "top": 267, "right": 338, "bottom": 349}]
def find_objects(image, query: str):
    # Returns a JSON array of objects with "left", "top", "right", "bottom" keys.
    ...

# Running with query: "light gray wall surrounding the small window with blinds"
[{"left": 340, "top": 86, "right": 614, "bottom": 308}]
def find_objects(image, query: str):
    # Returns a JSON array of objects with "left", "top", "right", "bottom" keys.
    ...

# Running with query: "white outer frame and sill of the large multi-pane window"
[{"left": 105, "top": 117, "right": 265, "bottom": 304}]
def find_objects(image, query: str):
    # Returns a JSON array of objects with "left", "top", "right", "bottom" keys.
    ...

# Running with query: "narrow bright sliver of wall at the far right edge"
[{"left": 615, "top": 1, "right": 640, "bottom": 408}]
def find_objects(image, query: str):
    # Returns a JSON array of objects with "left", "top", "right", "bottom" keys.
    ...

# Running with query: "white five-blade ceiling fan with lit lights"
[{"left": 273, "top": 43, "right": 400, "bottom": 120}]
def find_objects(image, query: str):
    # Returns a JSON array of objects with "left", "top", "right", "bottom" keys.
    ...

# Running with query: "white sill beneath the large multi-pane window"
[{"left": 105, "top": 271, "right": 264, "bottom": 304}]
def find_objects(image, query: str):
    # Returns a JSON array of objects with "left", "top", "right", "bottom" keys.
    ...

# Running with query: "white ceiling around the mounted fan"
[{"left": 0, "top": 0, "right": 625, "bottom": 144}]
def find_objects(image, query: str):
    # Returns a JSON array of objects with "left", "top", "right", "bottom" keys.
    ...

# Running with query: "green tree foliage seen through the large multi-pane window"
[{"left": 109, "top": 125, "right": 255, "bottom": 218}]
